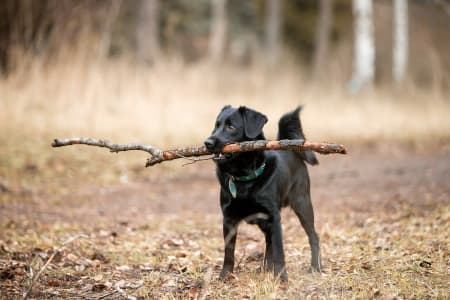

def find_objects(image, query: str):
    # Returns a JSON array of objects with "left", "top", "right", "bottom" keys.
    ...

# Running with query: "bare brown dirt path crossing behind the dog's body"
[{"left": 0, "top": 150, "right": 450, "bottom": 227}]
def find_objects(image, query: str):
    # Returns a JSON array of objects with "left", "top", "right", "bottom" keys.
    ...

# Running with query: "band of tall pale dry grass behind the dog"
[{"left": 0, "top": 56, "right": 450, "bottom": 146}]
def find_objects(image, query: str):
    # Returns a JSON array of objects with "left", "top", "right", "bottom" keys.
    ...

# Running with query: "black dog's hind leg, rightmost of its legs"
[{"left": 289, "top": 195, "right": 322, "bottom": 272}]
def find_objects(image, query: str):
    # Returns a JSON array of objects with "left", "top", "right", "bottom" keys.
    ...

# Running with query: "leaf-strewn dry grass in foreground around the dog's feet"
[{"left": 0, "top": 206, "right": 450, "bottom": 299}]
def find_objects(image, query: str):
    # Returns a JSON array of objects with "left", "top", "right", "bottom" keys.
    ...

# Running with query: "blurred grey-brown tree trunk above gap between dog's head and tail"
[{"left": 265, "top": 0, "right": 283, "bottom": 66}]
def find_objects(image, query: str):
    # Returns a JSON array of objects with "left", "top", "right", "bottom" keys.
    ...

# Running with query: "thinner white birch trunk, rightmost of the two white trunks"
[{"left": 392, "top": 0, "right": 408, "bottom": 84}]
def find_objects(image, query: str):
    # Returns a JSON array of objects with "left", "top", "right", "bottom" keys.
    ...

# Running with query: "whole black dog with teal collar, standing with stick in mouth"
[{"left": 205, "top": 106, "right": 321, "bottom": 281}]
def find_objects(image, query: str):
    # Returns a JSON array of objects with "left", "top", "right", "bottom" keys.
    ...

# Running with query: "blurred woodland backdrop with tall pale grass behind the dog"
[{"left": 0, "top": 0, "right": 450, "bottom": 145}]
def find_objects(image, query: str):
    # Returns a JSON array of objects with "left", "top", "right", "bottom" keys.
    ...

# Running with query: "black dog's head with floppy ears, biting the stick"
[{"left": 205, "top": 105, "right": 267, "bottom": 153}]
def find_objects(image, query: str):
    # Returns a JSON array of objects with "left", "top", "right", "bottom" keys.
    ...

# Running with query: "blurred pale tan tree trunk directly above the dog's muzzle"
[{"left": 208, "top": 0, "right": 227, "bottom": 62}]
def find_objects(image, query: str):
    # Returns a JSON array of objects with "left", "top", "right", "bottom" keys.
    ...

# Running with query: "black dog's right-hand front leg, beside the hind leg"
[{"left": 271, "top": 214, "right": 287, "bottom": 281}]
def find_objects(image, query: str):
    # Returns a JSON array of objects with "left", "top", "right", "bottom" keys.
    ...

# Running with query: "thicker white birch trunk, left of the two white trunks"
[{"left": 350, "top": 0, "right": 375, "bottom": 93}]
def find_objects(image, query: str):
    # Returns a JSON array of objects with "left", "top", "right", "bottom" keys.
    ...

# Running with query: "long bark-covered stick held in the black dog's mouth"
[{"left": 52, "top": 138, "right": 347, "bottom": 167}]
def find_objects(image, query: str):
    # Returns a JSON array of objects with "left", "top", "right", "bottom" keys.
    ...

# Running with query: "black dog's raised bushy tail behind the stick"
[{"left": 278, "top": 106, "right": 319, "bottom": 165}]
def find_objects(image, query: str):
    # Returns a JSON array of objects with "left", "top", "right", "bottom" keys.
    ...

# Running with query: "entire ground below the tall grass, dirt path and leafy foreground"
[{"left": 0, "top": 145, "right": 450, "bottom": 299}]
